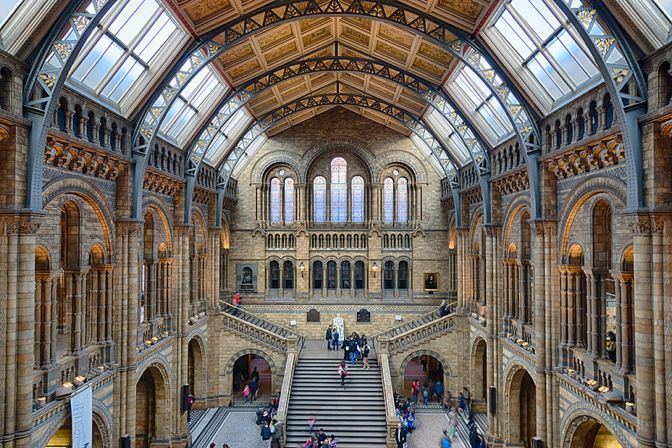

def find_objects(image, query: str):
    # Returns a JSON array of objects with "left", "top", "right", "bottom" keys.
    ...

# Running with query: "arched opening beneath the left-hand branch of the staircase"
[{"left": 226, "top": 350, "right": 276, "bottom": 401}]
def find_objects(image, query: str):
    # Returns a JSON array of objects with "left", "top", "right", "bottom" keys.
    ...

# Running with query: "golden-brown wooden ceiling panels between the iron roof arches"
[{"left": 171, "top": 0, "right": 492, "bottom": 135}]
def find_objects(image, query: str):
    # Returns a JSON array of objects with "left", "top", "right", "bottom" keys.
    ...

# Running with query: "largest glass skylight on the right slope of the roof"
[{"left": 492, "top": 0, "right": 600, "bottom": 103}]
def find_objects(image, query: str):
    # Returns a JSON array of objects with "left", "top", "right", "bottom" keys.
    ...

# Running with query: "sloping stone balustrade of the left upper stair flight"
[{"left": 220, "top": 302, "right": 302, "bottom": 353}]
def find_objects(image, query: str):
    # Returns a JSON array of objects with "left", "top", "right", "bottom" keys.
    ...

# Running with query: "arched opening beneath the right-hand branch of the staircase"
[{"left": 399, "top": 350, "right": 448, "bottom": 402}]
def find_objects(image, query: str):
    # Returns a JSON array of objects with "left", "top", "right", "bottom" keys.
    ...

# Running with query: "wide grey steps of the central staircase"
[{"left": 286, "top": 341, "right": 386, "bottom": 448}]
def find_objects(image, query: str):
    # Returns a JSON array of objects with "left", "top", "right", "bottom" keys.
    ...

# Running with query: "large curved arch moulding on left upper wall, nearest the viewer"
[{"left": 42, "top": 177, "right": 115, "bottom": 262}]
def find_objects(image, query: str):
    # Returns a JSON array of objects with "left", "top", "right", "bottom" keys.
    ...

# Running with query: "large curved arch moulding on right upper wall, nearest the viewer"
[{"left": 558, "top": 175, "right": 627, "bottom": 260}]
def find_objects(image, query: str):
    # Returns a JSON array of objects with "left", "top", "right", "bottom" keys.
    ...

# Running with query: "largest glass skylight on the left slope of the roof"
[{"left": 71, "top": 0, "right": 184, "bottom": 103}]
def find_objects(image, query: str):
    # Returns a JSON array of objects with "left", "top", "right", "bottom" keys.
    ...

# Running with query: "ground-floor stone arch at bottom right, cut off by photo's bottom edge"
[{"left": 560, "top": 408, "right": 631, "bottom": 448}]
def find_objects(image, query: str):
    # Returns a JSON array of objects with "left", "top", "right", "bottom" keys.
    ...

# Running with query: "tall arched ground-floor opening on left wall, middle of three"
[{"left": 133, "top": 362, "right": 171, "bottom": 443}]
